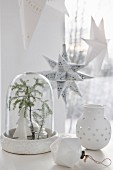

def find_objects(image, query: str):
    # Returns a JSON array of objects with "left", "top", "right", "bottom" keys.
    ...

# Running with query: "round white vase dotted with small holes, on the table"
[{"left": 76, "top": 104, "right": 111, "bottom": 150}]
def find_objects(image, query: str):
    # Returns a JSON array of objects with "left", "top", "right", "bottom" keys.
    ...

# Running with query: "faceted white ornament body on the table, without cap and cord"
[{"left": 50, "top": 137, "right": 82, "bottom": 167}]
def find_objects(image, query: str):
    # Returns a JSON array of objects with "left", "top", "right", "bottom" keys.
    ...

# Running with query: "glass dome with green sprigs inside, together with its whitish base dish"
[{"left": 2, "top": 72, "right": 57, "bottom": 154}]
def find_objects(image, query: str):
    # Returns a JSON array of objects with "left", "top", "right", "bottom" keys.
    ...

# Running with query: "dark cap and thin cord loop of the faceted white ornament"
[{"left": 80, "top": 151, "right": 112, "bottom": 167}]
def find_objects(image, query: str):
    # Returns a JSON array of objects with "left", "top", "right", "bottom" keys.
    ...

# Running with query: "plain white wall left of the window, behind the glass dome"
[{"left": 1, "top": 0, "right": 64, "bottom": 134}]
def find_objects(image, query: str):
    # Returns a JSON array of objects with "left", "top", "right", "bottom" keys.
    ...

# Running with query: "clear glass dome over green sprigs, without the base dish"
[{"left": 5, "top": 72, "right": 54, "bottom": 140}]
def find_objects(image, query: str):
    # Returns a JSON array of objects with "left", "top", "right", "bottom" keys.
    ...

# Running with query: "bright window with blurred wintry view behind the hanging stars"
[{"left": 65, "top": 0, "right": 113, "bottom": 133}]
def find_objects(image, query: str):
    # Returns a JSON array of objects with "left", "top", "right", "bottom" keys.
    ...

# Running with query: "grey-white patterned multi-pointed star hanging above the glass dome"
[{"left": 41, "top": 44, "right": 92, "bottom": 102}]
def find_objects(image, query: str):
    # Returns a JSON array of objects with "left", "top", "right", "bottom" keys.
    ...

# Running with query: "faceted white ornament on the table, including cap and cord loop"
[{"left": 50, "top": 135, "right": 112, "bottom": 168}]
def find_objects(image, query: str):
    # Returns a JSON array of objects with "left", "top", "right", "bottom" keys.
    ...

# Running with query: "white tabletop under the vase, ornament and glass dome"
[{"left": 0, "top": 121, "right": 113, "bottom": 170}]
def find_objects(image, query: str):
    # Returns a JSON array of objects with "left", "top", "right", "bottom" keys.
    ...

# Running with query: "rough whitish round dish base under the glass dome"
[{"left": 1, "top": 129, "right": 58, "bottom": 154}]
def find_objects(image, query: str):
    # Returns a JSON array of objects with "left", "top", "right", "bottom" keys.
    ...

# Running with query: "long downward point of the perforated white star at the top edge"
[{"left": 19, "top": 0, "right": 46, "bottom": 48}]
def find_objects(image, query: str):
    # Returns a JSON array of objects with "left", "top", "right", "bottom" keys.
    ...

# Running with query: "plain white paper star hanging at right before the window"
[{"left": 83, "top": 15, "right": 108, "bottom": 71}]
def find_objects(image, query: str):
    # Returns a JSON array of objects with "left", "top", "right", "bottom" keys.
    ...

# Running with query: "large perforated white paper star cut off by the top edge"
[{"left": 18, "top": 0, "right": 68, "bottom": 48}]
